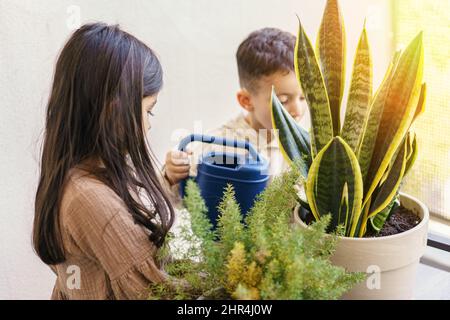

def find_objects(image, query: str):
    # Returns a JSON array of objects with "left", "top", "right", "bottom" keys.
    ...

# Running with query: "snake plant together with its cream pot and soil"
[{"left": 271, "top": 0, "right": 429, "bottom": 299}]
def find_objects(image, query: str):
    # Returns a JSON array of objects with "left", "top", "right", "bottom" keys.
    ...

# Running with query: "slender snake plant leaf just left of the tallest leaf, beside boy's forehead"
[{"left": 294, "top": 19, "right": 333, "bottom": 157}]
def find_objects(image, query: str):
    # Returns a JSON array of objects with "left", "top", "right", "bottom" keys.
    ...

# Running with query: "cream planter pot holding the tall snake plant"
[{"left": 293, "top": 193, "right": 429, "bottom": 299}]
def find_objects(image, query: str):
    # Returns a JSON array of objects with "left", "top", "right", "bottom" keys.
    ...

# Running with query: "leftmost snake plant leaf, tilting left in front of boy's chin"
[{"left": 271, "top": 90, "right": 312, "bottom": 179}]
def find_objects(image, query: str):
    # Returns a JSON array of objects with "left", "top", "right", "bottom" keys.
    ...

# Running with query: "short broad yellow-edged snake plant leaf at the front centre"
[{"left": 306, "top": 136, "right": 363, "bottom": 236}]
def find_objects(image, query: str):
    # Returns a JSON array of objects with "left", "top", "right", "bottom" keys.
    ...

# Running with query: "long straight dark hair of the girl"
[{"left": 33, "top": 23, "right": 174, "bottom": 265}]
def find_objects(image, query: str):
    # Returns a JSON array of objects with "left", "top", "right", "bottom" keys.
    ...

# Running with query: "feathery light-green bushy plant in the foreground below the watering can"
[{"left": 150, "top": 170, "right": 365, "bottom": 300}]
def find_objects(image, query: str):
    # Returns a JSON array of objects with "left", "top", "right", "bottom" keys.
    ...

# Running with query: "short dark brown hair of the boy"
[{"left": 236, "top": 28, "right": 296, "bottom": 91}]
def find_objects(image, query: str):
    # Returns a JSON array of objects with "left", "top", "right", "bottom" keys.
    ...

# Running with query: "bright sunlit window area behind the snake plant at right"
[{"left": 392, "top": 0, "right": 450, "bottom": 220}]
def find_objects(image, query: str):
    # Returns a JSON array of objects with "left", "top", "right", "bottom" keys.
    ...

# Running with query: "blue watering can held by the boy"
[{"left": 178, "top": 134, "right": 269, "bottom": 229}]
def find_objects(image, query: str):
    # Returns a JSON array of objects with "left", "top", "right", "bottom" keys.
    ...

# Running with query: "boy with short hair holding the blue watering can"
[{"left": 164, "top": 28, "right": 306, "bottom": 186}]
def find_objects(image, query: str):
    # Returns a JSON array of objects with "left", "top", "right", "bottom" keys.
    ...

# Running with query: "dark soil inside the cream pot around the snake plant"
[{"left": 299, "top": 205, "right": 421, "bottom": 238}]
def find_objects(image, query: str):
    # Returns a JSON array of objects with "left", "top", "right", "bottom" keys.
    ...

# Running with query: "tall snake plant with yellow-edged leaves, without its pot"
[{"left": 271, "top": 0, "right": 426, "bottom": 237}]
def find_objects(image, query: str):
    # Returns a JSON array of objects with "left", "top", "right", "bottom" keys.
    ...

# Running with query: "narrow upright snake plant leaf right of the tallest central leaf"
[{"left": 341, "top": 23, "right": 372, "bottom": 152}]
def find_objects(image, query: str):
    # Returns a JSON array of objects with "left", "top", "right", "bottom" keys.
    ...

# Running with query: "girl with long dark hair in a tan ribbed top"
[{"left": 33, "top": 23, "right": 174, "bottom": 299}]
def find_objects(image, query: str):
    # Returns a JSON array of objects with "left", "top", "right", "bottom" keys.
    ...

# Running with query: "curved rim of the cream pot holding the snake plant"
[{"left": 294, "top": 192, "right": 430, "bottom": 242}]
